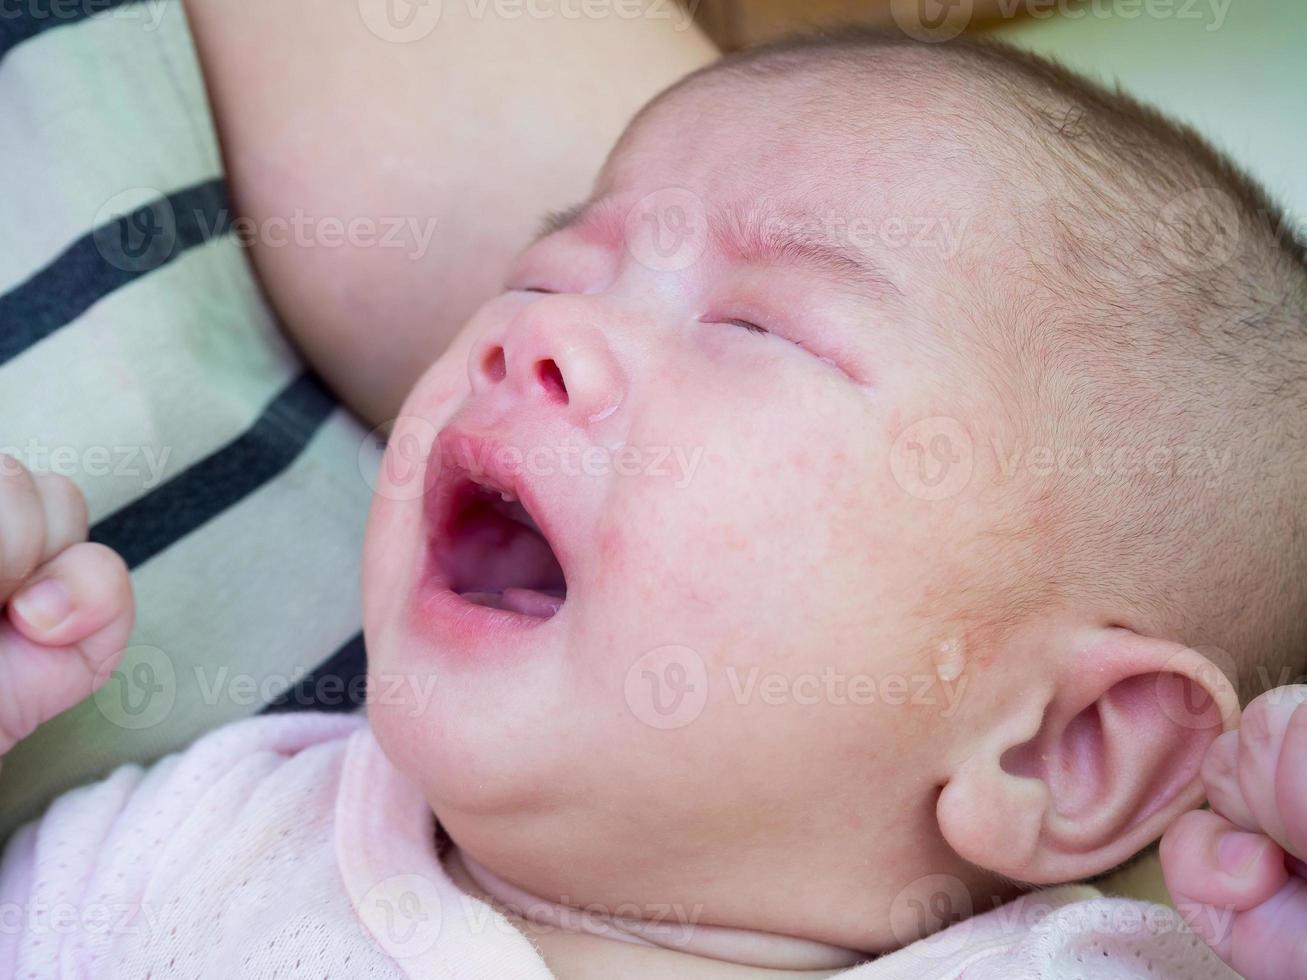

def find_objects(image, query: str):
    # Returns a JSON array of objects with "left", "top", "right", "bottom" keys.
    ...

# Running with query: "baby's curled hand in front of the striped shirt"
[{"left": 0, "top": 455, "right": 135, "bottom": 755}]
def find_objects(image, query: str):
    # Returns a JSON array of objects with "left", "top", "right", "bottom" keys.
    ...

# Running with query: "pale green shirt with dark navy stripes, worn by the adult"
[{"left": 0, "top": 0, "right": 379, "bottom": 834}]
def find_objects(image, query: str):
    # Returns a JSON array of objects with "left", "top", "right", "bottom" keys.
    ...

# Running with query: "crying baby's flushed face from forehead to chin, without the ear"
[{"left": 365, "top": 78, "right": 1003, "bottom": 949}]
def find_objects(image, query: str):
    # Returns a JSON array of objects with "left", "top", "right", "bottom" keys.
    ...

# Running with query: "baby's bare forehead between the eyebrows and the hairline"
[{"left": 592, "top": 67, "right": 1009, "bottom": 287}]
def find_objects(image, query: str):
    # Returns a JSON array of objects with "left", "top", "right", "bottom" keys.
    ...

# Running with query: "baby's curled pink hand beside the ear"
[{"left": 1162, "top": 686, "right": 1307, "bottom": 980}]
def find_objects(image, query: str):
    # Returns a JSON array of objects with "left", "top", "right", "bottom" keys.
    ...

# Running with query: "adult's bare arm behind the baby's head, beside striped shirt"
[{"left": 187, "top": 0, "right": 716, "bottom": 423}]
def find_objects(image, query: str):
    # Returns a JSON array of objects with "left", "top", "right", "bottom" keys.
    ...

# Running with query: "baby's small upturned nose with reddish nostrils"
[{"left": 468, "top": 297, "right": 626, "bottom": 426}]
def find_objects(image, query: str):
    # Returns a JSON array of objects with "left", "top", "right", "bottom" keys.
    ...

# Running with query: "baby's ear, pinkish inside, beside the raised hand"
[{"left": 936, "top": 627, "right": 1239, "bottom": 885}]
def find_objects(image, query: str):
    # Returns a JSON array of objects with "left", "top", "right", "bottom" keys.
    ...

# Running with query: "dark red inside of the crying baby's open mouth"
[{"left": 431, "top": 474, "right": 567, "bottom": 619}]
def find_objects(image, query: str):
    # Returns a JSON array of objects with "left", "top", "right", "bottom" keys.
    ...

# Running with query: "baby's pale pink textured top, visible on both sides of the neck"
[{"left": 0, "top": 715, "right": 1234, "bottom": 980}]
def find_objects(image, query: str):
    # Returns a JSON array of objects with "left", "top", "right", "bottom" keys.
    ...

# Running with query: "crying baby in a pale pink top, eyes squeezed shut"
[{"left": 0, "top": 26, "right": 1307, "bottom": 980}]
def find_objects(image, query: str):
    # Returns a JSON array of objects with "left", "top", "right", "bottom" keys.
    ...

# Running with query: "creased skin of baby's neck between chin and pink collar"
[{"left": 444, "top": 848, "right": 864, "bottom": 980}]
